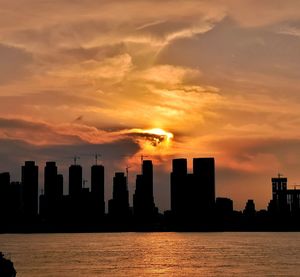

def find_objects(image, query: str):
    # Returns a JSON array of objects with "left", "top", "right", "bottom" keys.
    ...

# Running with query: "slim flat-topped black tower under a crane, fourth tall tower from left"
[{"left": 91, "top": 165, "right": 105, "bottom": 217}]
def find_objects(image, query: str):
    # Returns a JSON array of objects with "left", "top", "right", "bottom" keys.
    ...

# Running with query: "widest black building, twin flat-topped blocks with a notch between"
[{"left": 171, "top": 158, "right": 215, "bottom": 227}]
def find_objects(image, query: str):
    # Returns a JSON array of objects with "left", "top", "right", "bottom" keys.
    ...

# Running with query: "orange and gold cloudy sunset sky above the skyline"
[{"left": 0, "top": 0, "right": 300, "bottom": 211}]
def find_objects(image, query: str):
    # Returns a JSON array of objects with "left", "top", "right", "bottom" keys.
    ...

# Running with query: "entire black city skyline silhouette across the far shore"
[{"left": 0, "top": 158, "right": 300, "bottom": 230}]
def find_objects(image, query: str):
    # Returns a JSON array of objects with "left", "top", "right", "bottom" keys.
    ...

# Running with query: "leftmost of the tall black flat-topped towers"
[{"left": 22, "top": 161, "right": 39, "bottom": 218}]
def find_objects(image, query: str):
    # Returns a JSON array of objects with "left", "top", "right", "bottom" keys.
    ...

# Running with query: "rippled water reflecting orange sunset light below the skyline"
[{"left": 0, "top": 233, "right": 300, "bottom": 277}]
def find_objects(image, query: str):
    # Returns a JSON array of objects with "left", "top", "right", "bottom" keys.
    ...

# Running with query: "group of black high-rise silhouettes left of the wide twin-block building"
[{"left": 0, "top": 156, "right": 158, "bottom": 223}]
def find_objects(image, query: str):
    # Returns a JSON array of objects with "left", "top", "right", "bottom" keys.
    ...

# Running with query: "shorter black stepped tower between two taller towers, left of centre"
[{"left": 108, "top": 172, "right": 129, "bottom": 220}]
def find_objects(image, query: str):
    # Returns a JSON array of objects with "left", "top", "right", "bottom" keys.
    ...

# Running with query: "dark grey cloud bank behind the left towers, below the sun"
[{"left": 0, "top": 136, "right": 140, "bottom": 207}]
